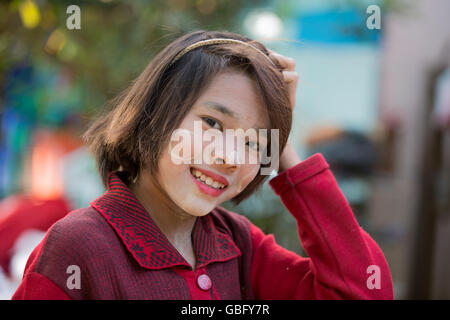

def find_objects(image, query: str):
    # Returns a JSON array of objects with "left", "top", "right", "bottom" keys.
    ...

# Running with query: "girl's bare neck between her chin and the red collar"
[{"left": 129, "top": 171, "right": 197, "bottom": 244}]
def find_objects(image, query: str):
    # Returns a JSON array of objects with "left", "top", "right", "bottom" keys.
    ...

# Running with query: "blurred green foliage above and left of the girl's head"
[{"left": 0, "top": 0, "right": 267, "bottom": 119}]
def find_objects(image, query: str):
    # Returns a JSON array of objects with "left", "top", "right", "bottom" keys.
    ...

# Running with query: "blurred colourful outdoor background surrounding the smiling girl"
[{"left": 0, "top": 0, "right": 450, "bottom": 299}]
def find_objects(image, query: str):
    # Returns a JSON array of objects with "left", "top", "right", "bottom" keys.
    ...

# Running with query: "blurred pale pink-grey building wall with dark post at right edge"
[{"left": 372, "top": 0, "right": 450, "bottom": 299}]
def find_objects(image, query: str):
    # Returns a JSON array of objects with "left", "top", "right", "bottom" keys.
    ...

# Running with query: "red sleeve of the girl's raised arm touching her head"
[{"left": 250, "top": 153, "right": 393, "bottom": 299}]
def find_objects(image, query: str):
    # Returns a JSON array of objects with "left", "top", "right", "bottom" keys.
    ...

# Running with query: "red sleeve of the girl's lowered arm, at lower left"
[{"left": 11, "top": 233, "right": 70, "bottom": 300}]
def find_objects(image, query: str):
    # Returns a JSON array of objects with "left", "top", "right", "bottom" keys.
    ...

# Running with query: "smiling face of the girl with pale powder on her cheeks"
[{"left": 143, "top": 71, "right": 268, "bottom": 216}]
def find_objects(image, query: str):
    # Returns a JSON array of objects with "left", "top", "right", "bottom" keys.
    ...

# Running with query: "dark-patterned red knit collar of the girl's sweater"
[{"left": 91, "top": 172, "right": 241, "bottom": 269}]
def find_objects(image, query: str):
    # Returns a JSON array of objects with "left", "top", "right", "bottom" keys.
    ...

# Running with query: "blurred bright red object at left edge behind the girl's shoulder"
[{"left": 0, "top": 195, "right": 70, "bottom": 275}]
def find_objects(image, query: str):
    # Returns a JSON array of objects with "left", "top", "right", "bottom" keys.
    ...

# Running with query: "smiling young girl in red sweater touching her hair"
[{"left": 13, "top": 31, "right": 393, "bottom": 299}]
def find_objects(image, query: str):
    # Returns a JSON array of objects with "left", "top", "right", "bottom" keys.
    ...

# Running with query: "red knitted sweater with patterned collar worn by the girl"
[{"left": 13, "top": 154, "right": 393, "bottom": 299}]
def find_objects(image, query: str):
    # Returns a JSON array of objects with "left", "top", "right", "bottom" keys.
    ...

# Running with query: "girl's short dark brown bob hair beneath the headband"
[{"left": 83, "top": 30, "right": 292, "bottom": 204}]
